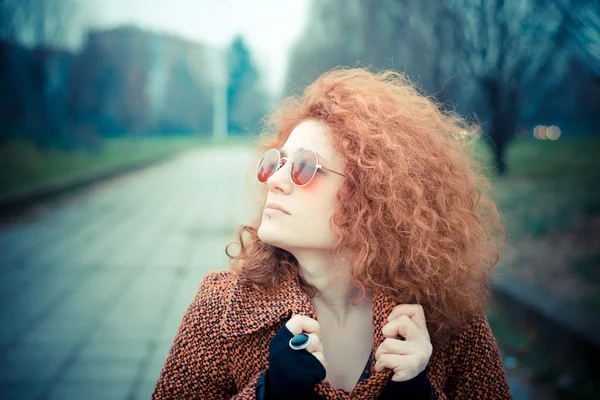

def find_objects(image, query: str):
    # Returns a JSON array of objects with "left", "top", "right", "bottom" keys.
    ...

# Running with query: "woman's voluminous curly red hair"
[{"left": 226, "top": 68, "right": 506, "bottom": 345}]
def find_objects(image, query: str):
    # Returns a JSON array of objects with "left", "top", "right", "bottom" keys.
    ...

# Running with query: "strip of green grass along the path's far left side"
[{"left": 0, "top": 136, "right": 255, "bottom": 196}]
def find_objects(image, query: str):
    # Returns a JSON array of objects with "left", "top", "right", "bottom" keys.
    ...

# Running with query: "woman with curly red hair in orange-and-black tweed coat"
[{"left": 153, "top": 69, "right": 510, "bottom": 399}]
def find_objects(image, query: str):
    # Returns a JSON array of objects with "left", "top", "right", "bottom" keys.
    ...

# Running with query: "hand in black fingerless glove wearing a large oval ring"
[{"left": 265, "top": 315, "right": 327, "bottom": 399}]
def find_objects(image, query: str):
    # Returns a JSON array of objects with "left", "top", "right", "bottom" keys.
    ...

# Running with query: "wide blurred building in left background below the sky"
[{"left": 70, "top": 27, "right": 216, "bottom": 139}]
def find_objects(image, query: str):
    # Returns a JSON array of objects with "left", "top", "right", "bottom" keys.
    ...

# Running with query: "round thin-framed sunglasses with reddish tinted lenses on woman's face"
[{"left": 256, "top": 149, "right": 346, "bottom": 186}]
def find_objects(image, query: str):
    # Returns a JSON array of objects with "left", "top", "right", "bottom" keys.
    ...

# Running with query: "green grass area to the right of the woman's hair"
[{"left": 480, "top": 138, "right": 600, "bottom": 240}]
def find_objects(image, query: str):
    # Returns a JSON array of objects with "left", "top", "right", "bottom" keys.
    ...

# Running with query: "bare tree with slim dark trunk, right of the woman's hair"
[{"left": 440, "top": 0, "right": 568, "bottom": 174}]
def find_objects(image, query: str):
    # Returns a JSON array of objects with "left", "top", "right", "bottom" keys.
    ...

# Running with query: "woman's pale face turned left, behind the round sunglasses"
[{"left": 258, "top": 120, "right": 344, "bottom": 252}]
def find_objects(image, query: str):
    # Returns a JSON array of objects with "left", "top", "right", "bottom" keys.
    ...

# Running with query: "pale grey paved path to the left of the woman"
[{"left": 0, "top": 148, "right": 528, "bottom": 400}]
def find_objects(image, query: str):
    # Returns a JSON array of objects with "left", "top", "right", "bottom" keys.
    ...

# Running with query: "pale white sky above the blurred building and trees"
[{"left": 83, "top": 0, "right": 311, "bottom": 95}]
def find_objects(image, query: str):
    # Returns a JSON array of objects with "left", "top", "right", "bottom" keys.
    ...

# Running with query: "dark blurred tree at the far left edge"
[{"left": 0, "top": 0, "right": 83, "bottom": 147}]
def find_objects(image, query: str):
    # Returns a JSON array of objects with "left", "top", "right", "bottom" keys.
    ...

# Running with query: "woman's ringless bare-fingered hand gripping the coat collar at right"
[{"left": 375, "top": 304, "right": 433, "bottom": 382}]
